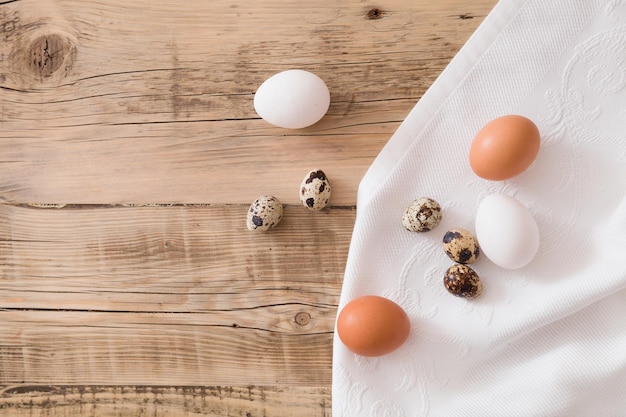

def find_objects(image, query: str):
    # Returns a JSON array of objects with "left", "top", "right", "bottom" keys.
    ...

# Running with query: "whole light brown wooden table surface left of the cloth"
[{"left": 0, "top": 0, "right": 496, "bottom": 417}]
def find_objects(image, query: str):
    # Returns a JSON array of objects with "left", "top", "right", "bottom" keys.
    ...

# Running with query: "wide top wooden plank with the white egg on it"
[{"left": 0, "top": 0, "right": 494, "bottom": 205}]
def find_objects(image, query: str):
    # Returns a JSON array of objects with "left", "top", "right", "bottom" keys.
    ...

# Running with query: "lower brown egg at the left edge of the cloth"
[{"left": 337, "top": 295, "right": 411, "bottom": 357}]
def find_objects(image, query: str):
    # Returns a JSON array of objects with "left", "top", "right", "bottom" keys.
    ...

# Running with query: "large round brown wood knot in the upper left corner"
[{"left": 26, "top": 34, "right": 75, "bottom": 81}]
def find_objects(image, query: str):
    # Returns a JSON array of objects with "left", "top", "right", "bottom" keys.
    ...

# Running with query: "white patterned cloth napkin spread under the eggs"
[{"left": 333, "top": 0, "right": 626, "bottom": 417}]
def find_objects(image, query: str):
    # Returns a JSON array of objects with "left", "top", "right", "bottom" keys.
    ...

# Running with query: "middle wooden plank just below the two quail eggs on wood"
[{"left": 0, "top": 204, "right": 355, "bottom": 312}]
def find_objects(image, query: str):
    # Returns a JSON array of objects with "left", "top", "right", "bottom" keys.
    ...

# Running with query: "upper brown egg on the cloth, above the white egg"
[{"left": 469, "top": 115, "right": 541, "bottom": 181}]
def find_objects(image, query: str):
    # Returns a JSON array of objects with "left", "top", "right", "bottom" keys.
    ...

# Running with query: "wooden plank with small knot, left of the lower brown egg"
[{"left": 0, "top": 306, "right": 333, "bottom": 387}]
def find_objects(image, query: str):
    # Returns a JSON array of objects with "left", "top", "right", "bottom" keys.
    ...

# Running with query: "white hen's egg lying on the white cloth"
[{"left": 475, "top": 193, "right": 539, "bottom": 269}]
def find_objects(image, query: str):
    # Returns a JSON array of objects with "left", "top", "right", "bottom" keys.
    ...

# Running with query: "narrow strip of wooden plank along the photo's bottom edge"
[{"left": 0, "top": 385, "right": 331, "bottom": 417}]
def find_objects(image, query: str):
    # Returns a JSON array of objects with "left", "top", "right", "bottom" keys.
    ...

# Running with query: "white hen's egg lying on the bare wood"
[{"left": 254, "top": 69, "right": 330, "bottom": 129}]
